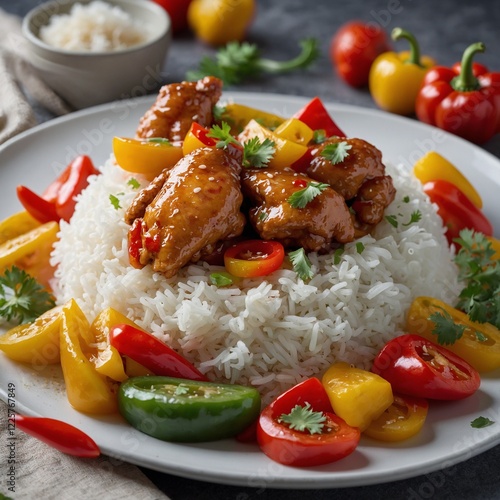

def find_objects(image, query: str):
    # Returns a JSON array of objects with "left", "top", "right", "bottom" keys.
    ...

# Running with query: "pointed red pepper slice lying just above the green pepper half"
[{"left": 109, "top": 324, "right": 208, "bottom": 382}]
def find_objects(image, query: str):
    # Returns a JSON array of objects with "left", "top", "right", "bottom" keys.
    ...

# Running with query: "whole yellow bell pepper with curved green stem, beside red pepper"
[{"left": 368, "top": 28, "right": 435, "bottom": 115}]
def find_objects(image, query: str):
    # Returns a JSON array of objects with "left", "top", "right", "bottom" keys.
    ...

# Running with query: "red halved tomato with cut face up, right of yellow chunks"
[{"left": 372, "top": 334, "right": 481, "bottom": 400}]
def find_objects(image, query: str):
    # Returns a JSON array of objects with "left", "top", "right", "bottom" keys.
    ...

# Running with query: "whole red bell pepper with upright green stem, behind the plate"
[{"left": 415, "top": 42, "right": 500, "bottom": 144}]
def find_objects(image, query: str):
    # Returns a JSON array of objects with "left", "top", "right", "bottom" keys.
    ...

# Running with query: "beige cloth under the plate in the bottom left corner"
[{"left": 0, "top": 401, "right": 168, "bottom": 500}]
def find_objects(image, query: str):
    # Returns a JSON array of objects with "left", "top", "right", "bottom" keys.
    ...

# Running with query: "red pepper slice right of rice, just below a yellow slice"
[{"left": 423, "top": 179, "right": 493, "bottom": 245}]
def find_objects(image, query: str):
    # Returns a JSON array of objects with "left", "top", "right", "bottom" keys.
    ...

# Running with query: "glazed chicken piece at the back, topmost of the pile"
[{"left": 136, "top": 76, "right": 222, "bottom": 142}]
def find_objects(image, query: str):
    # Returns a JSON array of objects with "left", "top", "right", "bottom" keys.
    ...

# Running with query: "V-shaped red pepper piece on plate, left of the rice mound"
[{"left": 17, "top": 155, "right": 99, "bottom": 224}]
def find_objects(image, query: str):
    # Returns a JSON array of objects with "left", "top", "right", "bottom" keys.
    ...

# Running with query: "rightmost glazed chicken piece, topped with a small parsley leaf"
[{"left": 306, "top": 137, "right": 396, "bottom": 226}]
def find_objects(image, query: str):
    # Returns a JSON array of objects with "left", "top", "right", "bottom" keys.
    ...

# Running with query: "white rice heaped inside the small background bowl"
[{"left": 40, "top": 0, "right": 147, "bottom": 52}]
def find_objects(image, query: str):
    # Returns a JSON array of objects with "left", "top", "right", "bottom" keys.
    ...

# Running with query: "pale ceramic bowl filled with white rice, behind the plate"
[{"left": 23, "top": 0, "right": 171, "bottom": 109}]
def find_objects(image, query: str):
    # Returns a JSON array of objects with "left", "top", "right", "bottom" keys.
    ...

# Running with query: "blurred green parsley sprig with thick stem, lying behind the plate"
[{"left": 186, "top": 38, "right": 319, "bottom": 85}]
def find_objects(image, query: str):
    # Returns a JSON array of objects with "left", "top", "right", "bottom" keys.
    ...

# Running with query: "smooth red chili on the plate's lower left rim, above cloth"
[{"left": 15, "top": 414, "right": 101, "bottom": 458}]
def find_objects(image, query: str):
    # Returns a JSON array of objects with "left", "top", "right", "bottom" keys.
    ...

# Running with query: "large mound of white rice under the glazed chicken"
[{"left": 53, "top": 161, "right": 460, "bottom": 401}]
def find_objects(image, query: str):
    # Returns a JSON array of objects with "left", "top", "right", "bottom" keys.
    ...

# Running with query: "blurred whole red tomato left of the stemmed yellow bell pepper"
[{"left": 330, "top": 21, "right": 391, "bottom": 87}]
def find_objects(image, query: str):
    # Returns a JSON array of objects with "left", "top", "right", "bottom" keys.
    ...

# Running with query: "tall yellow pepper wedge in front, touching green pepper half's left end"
[{"left": 60, "top": 299, "right": 118, "bottom": 414}]
